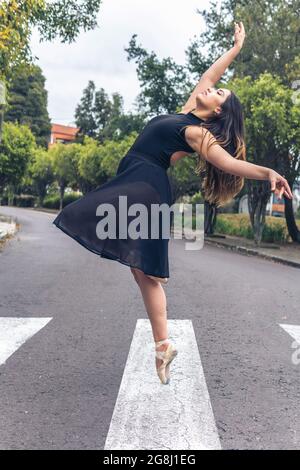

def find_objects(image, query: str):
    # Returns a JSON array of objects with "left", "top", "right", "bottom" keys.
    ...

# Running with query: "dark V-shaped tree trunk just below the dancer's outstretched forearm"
[{"left": 248, "top": 181, "right": 270, "bottom": 245}]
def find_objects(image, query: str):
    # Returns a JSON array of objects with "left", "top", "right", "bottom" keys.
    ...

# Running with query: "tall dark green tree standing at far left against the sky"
[{"left": 4, "top": 65, "right": 51, "bottom": 148}]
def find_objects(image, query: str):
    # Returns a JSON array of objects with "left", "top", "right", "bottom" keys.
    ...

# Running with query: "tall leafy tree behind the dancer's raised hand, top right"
[{"left": 187, "top": 0, "right": 300, "bottom": 86}]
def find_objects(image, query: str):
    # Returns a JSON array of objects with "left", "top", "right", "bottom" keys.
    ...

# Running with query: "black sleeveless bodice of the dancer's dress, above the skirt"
[{"left": 123, "top": 112, "right": 203, "bottom": 170}]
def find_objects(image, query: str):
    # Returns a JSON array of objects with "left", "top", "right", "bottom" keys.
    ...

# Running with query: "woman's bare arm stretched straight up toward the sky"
[{"left": 182, "top": 22, "right": 245, "bottom": 112}]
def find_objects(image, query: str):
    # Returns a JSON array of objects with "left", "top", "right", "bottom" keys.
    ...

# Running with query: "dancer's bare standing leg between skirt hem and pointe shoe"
[{"left": 130, "top": 268, "right": 168, "bottom": 367}]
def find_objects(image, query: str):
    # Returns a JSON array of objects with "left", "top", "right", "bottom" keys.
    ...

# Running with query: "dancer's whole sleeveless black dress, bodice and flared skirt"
[{"left": 53, "top": 112, "right": 202, "bottom": 278}]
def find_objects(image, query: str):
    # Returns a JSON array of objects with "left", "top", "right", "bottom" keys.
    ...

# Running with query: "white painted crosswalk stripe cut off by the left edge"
[{"left": 0, "top": 317, "right": 52, "bottom": 365}]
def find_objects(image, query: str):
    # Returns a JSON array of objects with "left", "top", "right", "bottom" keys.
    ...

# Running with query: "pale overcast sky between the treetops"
[{"left": 31, "top": 0, "right": 209, "bottom": 124}]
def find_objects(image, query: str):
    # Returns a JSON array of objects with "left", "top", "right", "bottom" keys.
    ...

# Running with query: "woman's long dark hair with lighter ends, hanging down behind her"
[{"left": 186, "top": 92, "right": 246, "bottom": 207}]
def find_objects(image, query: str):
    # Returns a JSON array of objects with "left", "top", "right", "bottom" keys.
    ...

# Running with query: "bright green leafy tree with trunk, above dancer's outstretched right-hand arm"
[{"left": 230, "top": 73, "right": 300, "bottom": 243}]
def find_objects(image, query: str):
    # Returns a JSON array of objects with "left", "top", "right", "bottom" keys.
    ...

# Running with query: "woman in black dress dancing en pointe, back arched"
[{"left": 53, "top": 22, "right": 293, "bottom": 384}]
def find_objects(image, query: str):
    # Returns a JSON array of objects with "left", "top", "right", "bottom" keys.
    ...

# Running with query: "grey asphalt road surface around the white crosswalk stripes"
[{"left": 0, "top": 206, "right": 300, "bottom": 449}]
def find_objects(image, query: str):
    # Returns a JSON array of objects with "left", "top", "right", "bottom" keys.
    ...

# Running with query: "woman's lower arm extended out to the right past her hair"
[{"left": 193, "top": 126, "right": 293, "bottom": 199}]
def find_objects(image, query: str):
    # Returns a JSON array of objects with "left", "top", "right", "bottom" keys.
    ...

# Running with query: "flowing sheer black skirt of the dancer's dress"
[{"left": 53, "top": 151, "right": 173, "bottom": 281}]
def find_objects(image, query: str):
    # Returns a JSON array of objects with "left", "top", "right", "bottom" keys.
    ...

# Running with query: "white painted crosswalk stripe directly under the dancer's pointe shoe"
[{"left": 104, "top": 319, "right": 221, "bottom": 450}]
